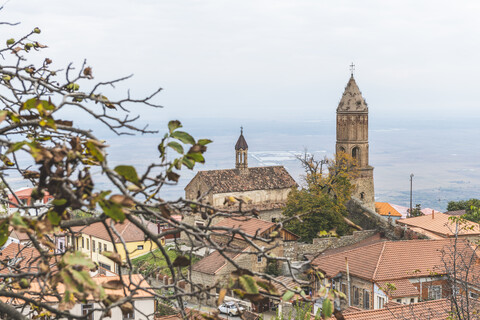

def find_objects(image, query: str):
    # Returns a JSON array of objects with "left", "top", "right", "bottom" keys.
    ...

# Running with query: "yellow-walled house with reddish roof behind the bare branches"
[{"left": 71, "top": 219, "right": 158, "bottom": 273}]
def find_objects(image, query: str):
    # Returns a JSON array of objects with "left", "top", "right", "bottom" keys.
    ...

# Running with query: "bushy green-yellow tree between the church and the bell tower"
[{"left": 283, "top": 153, "right": 357, "bottom": 242}]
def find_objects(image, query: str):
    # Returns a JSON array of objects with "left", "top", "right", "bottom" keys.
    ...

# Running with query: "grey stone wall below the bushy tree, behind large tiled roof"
[{"left": 283, "top": 230, "right": 378, "bottom": 260}]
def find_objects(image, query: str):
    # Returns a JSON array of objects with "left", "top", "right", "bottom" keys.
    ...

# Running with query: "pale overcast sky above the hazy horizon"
[{"left": 1, "top": 0, "right": 480, "bottom": 121}]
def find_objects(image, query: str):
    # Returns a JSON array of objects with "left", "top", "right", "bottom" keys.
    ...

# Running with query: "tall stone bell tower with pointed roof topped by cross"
[{"left": 335, "top": 64, "right": 375, "bottom": 211}]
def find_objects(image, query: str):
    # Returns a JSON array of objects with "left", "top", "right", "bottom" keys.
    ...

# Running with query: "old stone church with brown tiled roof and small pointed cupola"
[{"left": 185, "top": 130, "right": 296, "bottom": 222}]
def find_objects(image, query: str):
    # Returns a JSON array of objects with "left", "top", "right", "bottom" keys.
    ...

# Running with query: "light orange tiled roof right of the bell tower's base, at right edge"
[{"left": 396, "top": 212, "right": 480, "bottom": 237}]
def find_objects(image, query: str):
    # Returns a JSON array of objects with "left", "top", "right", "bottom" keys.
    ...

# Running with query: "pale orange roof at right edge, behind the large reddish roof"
[{"left": 396, "top": 212, "right": 480, "bottom": 241}]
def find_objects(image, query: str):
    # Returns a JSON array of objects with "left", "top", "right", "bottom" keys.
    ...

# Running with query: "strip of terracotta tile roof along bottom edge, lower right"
[{"left": 333, "top": 299, "right": 450, "bottom": 320}]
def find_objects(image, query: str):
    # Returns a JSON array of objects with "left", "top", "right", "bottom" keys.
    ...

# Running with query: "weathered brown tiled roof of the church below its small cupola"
[{"left": 185, "top": 166, "right": 296, "bottom": 193}]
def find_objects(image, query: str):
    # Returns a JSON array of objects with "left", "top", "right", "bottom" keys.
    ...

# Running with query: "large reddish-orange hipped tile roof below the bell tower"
[{"left": 312, "top": 239, "right": 467, "bottom": 281}]
